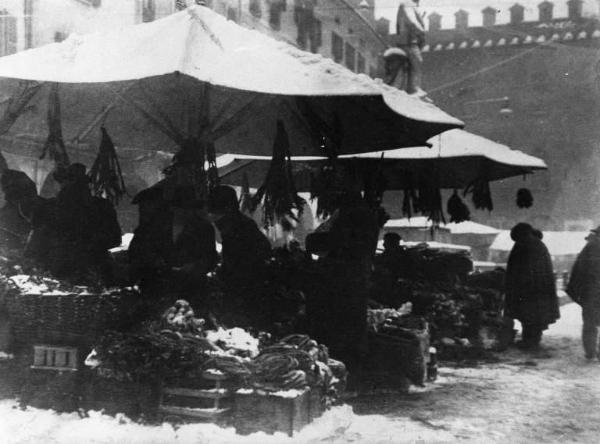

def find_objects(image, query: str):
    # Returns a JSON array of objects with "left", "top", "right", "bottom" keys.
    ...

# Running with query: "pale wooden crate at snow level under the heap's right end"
[{"left": 233, "top": 389, "right": 312, "bottom": 436}]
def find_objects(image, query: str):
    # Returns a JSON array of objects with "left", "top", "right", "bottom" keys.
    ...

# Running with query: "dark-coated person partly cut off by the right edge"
[{"left": 567, "top": 227, "right": 600, "bottom": 360}]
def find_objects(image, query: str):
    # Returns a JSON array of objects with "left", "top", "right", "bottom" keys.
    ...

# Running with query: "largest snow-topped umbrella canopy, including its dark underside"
[{"left": 0, "top": 6, "right": 462, "bottom": 161}]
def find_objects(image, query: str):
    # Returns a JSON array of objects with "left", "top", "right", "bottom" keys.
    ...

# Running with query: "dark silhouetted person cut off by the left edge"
[{"left": 0, "top": 170, "right": 42, "bottom": 252}]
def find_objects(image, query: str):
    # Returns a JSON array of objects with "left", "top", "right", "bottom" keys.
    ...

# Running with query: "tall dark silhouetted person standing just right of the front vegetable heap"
[{"left": 307, "top": 191, "right": 380, "bottom": 381}]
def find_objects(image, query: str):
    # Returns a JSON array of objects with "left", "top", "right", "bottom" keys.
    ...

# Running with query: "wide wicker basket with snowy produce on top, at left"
[{"left": 5, "top": 289, "right": 141, "bottom": 345}]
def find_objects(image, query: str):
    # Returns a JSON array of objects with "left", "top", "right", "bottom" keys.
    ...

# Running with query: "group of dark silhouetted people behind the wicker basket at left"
[{"left": 0, "top": 163, "right": 121, "bottom": 282}]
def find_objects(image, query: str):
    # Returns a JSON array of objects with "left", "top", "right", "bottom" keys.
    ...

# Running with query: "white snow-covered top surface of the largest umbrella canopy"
[{"left": 0, "top": 6, "right": 462, "bottom": 121}]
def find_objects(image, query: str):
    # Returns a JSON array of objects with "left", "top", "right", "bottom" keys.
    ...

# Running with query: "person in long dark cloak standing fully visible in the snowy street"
[{"left": 505, "top": 223, "right": 560, "bottom": 348}]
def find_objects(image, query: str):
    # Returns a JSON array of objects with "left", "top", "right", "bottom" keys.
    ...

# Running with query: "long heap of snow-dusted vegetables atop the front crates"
[{"left": 95, "top": 300, "right": 346, "bottom": 401}]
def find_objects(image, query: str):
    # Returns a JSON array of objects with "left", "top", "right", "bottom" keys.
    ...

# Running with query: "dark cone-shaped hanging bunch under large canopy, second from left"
[{"left": 89, "top": 127, "right": 127, "bottom": 205}]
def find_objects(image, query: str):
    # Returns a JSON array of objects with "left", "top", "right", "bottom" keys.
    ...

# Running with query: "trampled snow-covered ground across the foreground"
[{"left": 0, "top": 304, "right": 600, "bottom": 444}]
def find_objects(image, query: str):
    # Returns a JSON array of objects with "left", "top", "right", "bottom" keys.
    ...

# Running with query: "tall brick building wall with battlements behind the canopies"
[{"left": 392, "top": 0, "right": 600, "bottom": 230}]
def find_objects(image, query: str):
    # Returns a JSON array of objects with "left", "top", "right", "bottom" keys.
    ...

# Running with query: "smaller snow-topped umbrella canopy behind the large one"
[{"left": 219, "top": 129, "right": 547, "bottom": 190}]
